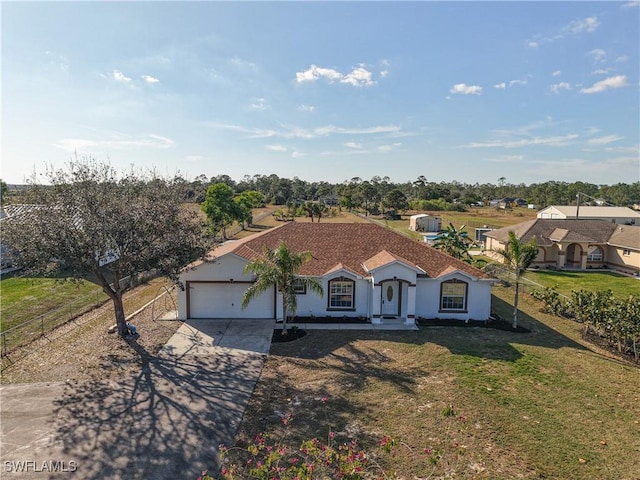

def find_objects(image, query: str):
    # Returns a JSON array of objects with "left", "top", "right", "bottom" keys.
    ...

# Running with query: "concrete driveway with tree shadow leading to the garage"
[{"left": 0, "top": 320, "right": 273, "bottom": 480}]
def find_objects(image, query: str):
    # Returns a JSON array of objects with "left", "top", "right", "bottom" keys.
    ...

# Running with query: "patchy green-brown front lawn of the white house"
[{"left": 235, "top": 287, "right": 640, "bottom": 480}]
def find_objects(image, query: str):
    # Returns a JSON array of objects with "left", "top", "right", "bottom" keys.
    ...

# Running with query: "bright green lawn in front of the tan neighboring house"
[{"left": 525, "top": 270, "right": 640, "bottom": 298}]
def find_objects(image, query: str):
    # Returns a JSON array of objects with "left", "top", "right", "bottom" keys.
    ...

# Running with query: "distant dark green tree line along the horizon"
[{"left": 183, "top": 174, "right": 640, "bottom": 212}]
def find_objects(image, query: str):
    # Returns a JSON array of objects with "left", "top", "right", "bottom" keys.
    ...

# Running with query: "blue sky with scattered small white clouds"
[{"left": 1, "top": 1, "right": 640, "bottom": 184}]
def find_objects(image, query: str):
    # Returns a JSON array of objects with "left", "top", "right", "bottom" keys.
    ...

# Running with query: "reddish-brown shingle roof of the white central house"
[{"left": 204, "top": 222, "right": 492, "bottom": 279}]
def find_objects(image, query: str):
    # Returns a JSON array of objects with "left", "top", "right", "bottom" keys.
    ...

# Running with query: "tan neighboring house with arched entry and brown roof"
[{"left": 485, "top": 219, "right": 640, "bottom": 275}]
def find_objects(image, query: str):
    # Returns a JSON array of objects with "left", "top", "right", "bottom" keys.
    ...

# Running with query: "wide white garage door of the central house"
[{"left": 189, "top": 282, "right": 273, "bottom": 318}]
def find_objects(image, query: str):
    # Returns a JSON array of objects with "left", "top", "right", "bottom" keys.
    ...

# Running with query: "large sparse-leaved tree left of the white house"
[{"left": 2, "top": 159, "right": 206, "bottom": 336}]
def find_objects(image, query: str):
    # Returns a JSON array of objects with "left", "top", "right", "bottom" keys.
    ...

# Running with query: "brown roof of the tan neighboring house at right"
[{"left": 486, "top": 218, "right": 640, "bottom": 250}]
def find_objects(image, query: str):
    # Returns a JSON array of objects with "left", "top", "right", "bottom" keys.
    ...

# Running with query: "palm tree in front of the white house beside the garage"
[{"left": 242, "top": 242, "right": 324, "bottom": 333}]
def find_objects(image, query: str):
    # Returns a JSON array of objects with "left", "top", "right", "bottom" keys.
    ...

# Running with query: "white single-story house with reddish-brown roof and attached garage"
[{"left": 178, "top": 222, "right": 496, "bottom": 323}]
